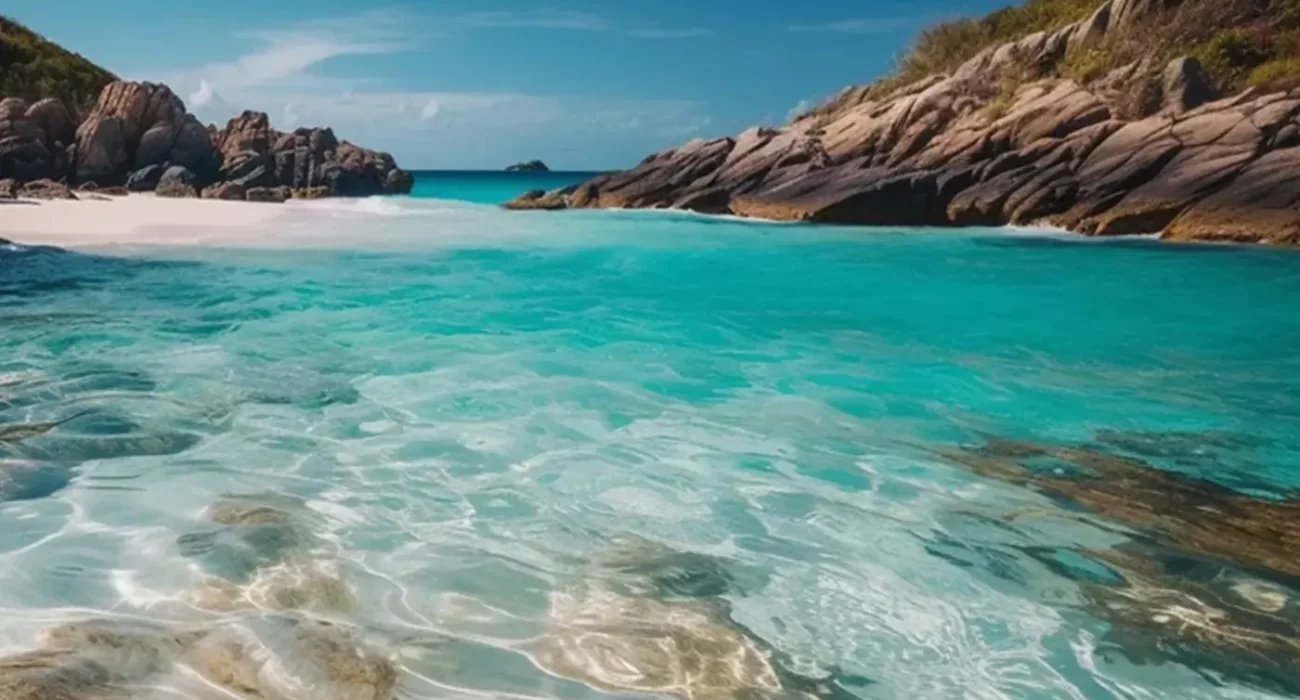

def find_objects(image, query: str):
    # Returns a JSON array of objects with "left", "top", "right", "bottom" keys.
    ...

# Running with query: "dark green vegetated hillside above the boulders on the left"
[{"left": 0, "top": 16, "right": 117, "bottom": 112}]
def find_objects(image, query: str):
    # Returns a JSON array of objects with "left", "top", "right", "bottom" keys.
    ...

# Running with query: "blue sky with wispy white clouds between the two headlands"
[{"left": 5, "top": 0, "right": 1005, "bottom": 169}]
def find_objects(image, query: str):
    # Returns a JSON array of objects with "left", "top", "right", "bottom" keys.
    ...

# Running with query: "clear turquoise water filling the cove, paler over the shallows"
[{"left": 0, "top": 200, "right": 1300, "bottom": 699}]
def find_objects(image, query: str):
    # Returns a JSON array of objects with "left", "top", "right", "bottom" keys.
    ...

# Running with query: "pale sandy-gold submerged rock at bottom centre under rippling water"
[{"left": 524, "top": 536, "right": 870, "bottom": 700}]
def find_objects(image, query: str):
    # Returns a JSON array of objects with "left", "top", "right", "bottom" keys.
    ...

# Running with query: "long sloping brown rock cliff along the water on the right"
[{"left": 507, "top": 0, "right": 1300, "bottom": 245}]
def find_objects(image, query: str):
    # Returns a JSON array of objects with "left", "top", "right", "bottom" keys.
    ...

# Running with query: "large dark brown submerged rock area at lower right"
[{"left": 928, "top": 432, "right": 1300, "bottom": 693}]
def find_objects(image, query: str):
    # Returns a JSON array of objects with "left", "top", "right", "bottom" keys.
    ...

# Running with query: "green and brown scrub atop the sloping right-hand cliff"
[{"left": 871, "top": 0, "right": 1300, "bottom": 104}]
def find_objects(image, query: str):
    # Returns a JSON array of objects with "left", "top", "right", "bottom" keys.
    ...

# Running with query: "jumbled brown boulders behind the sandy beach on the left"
[{"left": 0, "top": 82, "right": 413, "bottom": 200}]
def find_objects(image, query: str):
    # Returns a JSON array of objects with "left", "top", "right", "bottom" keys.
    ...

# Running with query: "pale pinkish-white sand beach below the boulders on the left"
[{"left": 0, "top": 195, "right": 286, "bottom": 247}]
